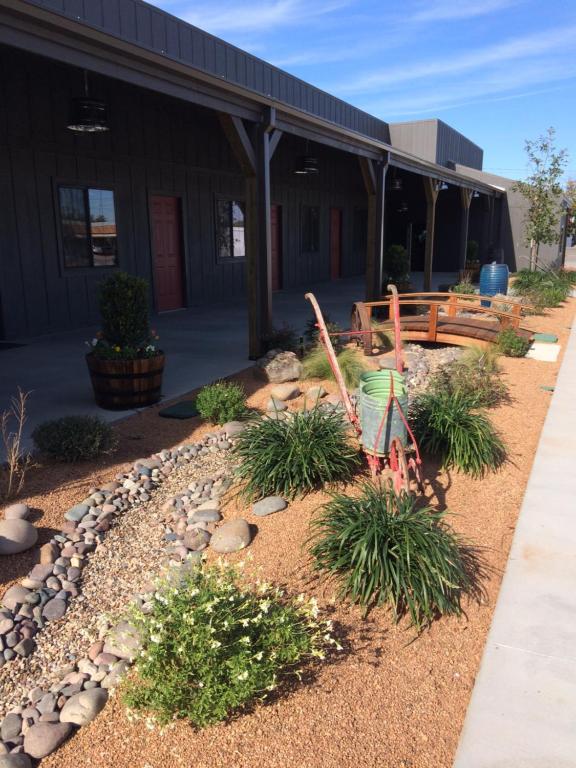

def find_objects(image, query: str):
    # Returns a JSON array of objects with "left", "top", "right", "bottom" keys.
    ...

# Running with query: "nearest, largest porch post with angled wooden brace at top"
[{"left": 220, "top": 114, "right": 280, "bottom": 360}]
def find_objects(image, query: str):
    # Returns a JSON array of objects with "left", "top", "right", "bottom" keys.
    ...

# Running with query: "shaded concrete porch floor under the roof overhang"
[{"left": 0, "top": 273, "right": 454, "bottom": 458}]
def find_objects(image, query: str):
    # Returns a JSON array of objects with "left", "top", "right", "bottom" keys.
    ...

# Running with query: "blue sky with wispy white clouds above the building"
[{"left": 153, "top": 0, "right": 576, "bottom": 178}]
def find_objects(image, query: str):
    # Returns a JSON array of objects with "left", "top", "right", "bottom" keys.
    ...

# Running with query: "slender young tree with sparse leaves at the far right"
[{"left": 514, "top": 128, "right": 567, "bottom": 269}]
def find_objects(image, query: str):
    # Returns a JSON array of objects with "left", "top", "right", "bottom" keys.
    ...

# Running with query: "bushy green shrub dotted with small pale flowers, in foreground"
[{"left": 122, "top": 566, "right": 339, "bottom": 728}]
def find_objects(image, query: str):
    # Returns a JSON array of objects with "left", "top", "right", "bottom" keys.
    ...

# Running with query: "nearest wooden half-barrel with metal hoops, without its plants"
[{"left": 86, "top": 353, "right": 164, "bottom": 411}]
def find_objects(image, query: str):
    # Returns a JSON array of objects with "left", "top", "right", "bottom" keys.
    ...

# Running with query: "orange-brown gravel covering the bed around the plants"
[{"left": 7, "top": 299, "right": 576, "bottom": 768}]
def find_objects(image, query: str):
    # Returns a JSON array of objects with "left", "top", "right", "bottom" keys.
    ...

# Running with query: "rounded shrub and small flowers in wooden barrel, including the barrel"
[{"left": 86, "top": 272, "right": 164, "bottom": 410}]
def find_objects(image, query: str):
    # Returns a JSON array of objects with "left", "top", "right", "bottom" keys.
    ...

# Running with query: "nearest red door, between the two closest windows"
[{"left": 150, "top": 195, "right": 184, "bottom": 312}]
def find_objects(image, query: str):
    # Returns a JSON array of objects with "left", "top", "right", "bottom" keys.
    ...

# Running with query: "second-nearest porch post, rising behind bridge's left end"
[{"left": 359, "top": 155, "right": 388, "bottom": 301}]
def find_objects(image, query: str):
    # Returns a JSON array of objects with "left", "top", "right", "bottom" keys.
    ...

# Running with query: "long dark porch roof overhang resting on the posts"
[{"left": 0, "top": 0, "right": 501, "bottom": 196}]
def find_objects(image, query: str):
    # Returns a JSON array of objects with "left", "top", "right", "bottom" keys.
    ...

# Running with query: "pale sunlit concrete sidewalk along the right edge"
[{"left": 454, "top": 316, "right": 576, "bottom": 768}]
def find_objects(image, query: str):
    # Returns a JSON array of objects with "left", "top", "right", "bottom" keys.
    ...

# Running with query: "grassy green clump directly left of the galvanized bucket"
[{"left": 235, "top": 408, "right": 360, "bottom": 499}]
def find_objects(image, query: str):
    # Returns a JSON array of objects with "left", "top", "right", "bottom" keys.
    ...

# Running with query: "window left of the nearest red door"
[{"left": 58, "top": 187, "right": 118, "bottom": 269}]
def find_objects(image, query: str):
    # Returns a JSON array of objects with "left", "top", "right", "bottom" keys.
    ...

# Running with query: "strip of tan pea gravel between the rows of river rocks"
[{"left": 0, "top": 453, "right": 230, "bottom": 718}]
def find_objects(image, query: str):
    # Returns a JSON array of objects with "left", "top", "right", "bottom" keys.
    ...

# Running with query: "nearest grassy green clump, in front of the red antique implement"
[{"left": 310, "top": 483, "right": 476, "bottom": 628}]
